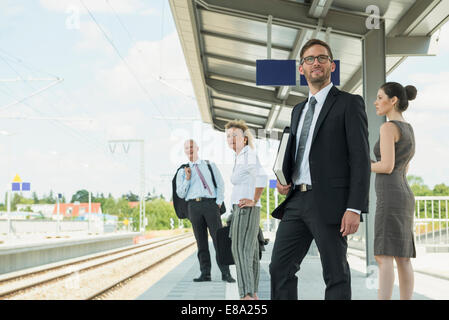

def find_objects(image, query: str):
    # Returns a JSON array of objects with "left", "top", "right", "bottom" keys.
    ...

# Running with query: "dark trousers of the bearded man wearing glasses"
[{"left": 270, "top": 190, "right": 351, "bottom": 300}]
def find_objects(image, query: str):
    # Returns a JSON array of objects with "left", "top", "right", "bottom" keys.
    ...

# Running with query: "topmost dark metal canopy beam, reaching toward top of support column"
[{"left": 195, "top": 0, "right": 369, "bottom": 39}]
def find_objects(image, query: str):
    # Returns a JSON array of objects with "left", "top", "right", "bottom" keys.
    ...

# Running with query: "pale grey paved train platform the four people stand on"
[{"left": 137, "top": 232, "right": 449, "bottom": 300}]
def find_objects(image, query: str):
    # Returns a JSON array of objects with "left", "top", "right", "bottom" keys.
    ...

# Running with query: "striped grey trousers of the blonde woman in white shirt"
[{"left": 229, "top": 204, "right": 260, "bottom": 298}]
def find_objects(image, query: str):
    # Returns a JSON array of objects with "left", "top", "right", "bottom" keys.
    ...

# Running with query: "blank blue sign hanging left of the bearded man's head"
[{"left": 256, "top": 60, "right": 296, "bottom": 86}]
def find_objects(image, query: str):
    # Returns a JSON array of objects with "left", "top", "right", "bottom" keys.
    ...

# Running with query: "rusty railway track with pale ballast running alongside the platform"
[{"left": 0, "top": 233, "right": 196, "bottom": 299}]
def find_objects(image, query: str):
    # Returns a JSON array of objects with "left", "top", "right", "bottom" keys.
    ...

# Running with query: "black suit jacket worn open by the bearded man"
[{"left": 272, "top": 86, "right": 371, "bottom": 224}]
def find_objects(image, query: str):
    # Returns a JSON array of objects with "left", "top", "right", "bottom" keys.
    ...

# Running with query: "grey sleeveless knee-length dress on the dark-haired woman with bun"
[{"left": 374, "top": 120, "right": 416, "bottom": 258}]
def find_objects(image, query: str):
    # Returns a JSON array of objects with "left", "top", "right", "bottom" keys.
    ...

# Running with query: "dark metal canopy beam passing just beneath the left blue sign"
[{"left": 206, "top": 78, "right": 304, "bottom": 107}]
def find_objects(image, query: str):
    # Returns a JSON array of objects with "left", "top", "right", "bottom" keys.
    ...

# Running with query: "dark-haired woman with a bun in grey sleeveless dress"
[{"left": 371, "top": 82, "right": 417, "bottom": 300}]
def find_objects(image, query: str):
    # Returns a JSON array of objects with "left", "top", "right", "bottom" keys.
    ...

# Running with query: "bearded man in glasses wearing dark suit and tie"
[{"left": 270, "top": 39, "right": 370, "bottom": 299}]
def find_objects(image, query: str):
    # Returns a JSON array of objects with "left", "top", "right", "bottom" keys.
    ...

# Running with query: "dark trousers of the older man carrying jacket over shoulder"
[{"left": 188, "top": 199, "right": 230, "bottom": 276}]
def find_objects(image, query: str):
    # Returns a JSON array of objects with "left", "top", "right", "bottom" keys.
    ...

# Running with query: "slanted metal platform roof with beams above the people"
[{"left": 170, "top": 0, "right": 449, "bottom": 136}]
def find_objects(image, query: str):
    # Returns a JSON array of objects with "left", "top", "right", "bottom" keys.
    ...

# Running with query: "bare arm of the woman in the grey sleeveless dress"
[{"left": 371, "top": 122, "right": 397, "bottom": 174}]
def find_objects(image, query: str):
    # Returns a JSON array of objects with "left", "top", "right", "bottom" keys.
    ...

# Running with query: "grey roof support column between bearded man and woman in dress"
[{"left": 362, "top": 19, "right": 386, "bottom": 276}]
